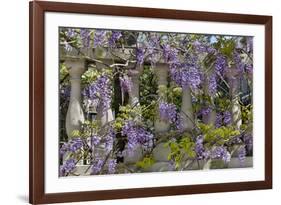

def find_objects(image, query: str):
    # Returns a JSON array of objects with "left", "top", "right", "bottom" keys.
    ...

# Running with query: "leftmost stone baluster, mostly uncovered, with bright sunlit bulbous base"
[{"left": 65, "top": 59, "right": 85, "bottom": 138}]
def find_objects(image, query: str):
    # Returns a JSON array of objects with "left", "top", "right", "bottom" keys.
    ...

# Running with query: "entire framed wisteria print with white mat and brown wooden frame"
[{"left": 30, "top": 1, "right": 272, "bottom": 204}]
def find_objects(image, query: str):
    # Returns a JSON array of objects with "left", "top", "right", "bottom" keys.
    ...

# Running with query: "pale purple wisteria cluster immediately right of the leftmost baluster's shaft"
[{"left": 82, "top": 75, "right": 112, "bottom": 112}]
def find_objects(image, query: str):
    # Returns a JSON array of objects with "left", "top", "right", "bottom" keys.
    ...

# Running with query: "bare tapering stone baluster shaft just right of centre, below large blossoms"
[{"left": 181, "top": 86, "right": 194, "bottom": 130}]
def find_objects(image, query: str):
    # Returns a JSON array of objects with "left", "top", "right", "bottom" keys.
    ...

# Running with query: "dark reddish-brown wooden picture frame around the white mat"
[{"left": 29, "top": 1, "right": 272, "bottom": 204}]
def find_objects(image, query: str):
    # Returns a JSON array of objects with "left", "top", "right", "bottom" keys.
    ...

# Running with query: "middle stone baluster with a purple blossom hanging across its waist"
[{"left": 154, "top": 63, "right": 170, "bottom": 132}]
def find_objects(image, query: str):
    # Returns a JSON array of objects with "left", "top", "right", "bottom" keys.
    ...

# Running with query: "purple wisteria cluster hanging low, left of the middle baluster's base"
[{"left": 121, "top": 120, "right": 153, "bottom": 152}]
